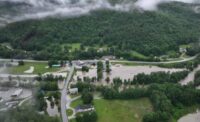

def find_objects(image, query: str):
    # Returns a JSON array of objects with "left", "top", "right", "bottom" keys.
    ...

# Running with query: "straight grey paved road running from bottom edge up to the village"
[{"left": 61, "top": 65, "right": 74, "bottom": 122}]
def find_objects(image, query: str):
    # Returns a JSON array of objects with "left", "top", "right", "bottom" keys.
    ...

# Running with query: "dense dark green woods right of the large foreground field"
[{"left": 143, "top": 84, "right": 200, "bottom": 122}]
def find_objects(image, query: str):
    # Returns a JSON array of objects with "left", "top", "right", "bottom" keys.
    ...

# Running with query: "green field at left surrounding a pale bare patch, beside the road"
[{"left": 8, "top": 62, "right": 59, "bottom": 74}]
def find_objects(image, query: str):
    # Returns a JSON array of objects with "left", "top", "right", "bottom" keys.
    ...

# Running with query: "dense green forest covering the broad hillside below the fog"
[{"left": 0, "top": 3, "right": 200, "bottom": 60}]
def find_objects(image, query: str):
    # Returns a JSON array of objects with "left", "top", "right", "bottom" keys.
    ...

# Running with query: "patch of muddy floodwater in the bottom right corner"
[{"left": 178, "top": 110, "right": 200, "bottom": 122}]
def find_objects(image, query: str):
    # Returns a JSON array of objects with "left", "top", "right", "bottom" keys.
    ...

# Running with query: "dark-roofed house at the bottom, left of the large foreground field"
[{"left": 75, "top": 104, "right": 95, "bottom": 113}]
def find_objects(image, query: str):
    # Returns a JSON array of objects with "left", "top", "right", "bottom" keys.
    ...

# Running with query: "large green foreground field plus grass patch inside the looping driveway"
[{"left": 71, "top": 98, "right": 153, "bottom": 122}]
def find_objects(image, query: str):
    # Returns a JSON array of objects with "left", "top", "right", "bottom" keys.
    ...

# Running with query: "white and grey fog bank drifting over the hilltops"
[{"left": 0, "top": 0, "right": 200, "bottom": 24}]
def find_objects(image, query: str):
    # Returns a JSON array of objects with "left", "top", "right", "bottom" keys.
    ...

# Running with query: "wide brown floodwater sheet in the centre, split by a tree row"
[{"left": 75, "top": 65, "right": 185, "bottom": 84}]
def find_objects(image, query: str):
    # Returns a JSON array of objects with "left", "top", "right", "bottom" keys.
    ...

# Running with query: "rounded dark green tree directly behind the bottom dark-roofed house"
[{"left": 81, "top": 90, "right": 93, "bottom": 104}]
